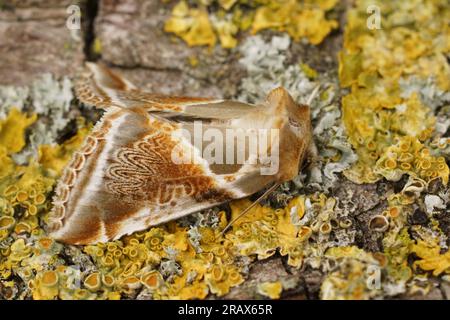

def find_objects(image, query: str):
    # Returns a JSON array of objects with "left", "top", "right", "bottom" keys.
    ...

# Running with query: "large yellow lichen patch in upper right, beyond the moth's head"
[{"left": 339, "top": 0, "right": 450, "bottom": 183}]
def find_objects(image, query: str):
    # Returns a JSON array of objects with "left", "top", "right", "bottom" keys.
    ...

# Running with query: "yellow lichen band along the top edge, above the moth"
[{"left": 164, "top": 0, "right": 338, "bottom": 48}]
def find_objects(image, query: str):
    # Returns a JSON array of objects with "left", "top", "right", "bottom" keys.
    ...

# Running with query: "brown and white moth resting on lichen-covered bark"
[{"left": 48, "top": 64, "right": 311, "bottom": 244}]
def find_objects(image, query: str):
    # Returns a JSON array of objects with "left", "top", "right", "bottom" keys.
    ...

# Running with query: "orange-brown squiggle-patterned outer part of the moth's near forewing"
[{"left": 49, "top": 110, "right": 251, "bottom": 244}]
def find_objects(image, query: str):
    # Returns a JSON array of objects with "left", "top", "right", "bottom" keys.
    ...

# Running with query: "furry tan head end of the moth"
[{"left": 266, "top": 87, "right": 311, "bottom": 181}]
